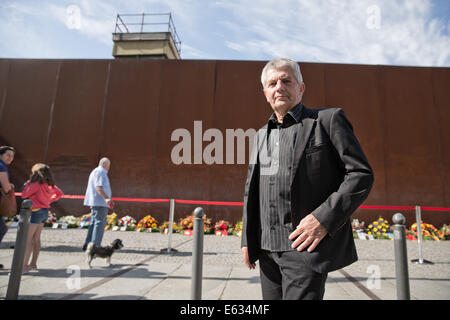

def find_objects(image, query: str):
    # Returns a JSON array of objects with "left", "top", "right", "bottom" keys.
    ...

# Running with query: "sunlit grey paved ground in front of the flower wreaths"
[{"left": 0, "top": 229, "right": 450, "bottom": 300}]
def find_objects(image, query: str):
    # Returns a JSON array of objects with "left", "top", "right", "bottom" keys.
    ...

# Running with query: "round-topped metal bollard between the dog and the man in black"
[{"left": 191, "top": 207, "right": 204, "bottom": 300}]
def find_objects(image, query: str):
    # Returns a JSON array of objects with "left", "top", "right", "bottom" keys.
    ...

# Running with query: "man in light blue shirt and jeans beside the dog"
[{"left": 83, "top": 158, "right": 113, "bottom": 250}]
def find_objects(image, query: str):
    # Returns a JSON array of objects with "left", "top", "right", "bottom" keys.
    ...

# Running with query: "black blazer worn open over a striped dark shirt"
[{"left": 241, "top": 106, "right": 374, "bottom": 272}]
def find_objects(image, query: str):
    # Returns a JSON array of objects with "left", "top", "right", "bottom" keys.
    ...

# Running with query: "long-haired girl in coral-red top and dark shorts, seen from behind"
[{"left": 22, "top": 163, "right": 64, "bottom": 273}]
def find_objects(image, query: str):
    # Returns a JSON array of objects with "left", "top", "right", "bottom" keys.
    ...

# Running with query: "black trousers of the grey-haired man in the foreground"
[{"left": 259, "top": 250, "right": 328, "bottom": 300}]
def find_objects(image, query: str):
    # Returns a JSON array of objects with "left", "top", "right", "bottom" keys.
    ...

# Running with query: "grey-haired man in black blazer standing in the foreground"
[{"left": 241, "top": 59, "right": 373, "bottom": 300}]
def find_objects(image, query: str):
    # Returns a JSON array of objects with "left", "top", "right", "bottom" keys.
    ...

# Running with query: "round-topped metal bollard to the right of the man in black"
[{"left": 392, "top": 213, "right": 410, "bottom": 300}]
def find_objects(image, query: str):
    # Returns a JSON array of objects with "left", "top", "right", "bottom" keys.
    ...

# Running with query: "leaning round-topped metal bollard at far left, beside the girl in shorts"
[{"left": 6, "top": 199, "right": 33, "bottom": 300}]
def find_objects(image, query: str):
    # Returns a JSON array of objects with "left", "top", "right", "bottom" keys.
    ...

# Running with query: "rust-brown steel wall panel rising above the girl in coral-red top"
[{"left": 0, "top": 60, "right": 60, "bottom": 190}]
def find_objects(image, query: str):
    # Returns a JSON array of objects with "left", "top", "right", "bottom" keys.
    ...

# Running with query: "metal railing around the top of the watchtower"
[{"left": 114, "top": 13, "right": 181, "bottom": 53}]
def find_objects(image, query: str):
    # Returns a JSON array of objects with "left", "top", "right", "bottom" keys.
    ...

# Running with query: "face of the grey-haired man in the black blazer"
[{"left": 264, "top": 67, "right": 305, "bottom": 114}]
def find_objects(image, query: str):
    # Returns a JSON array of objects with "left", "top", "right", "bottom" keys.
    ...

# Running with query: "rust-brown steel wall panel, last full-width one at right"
[{"left": 380, "top": 67, "right": 445, "bottom": 225}]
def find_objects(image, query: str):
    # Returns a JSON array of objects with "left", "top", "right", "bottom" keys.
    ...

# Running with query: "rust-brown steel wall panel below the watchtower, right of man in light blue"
[{"left": 100, "top": 60, "right": 167, "bottom": 216}]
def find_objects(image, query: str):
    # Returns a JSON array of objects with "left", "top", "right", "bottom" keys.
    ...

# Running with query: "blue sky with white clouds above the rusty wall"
[{"left": 0, "top": 0, "right": 450, "bottom": 67}]
